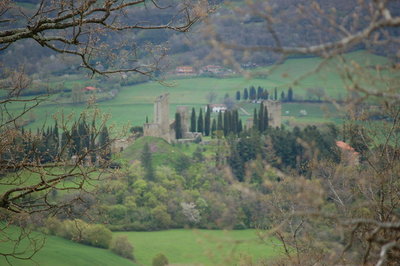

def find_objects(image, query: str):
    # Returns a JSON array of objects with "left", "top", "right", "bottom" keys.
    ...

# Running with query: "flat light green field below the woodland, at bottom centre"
[{"left": 114, "top": 229, "right": 281, "bottom": 265}]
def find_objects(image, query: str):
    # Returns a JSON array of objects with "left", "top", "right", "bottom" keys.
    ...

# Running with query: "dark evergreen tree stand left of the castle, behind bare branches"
[{"left": 0, "top": 118, "right": 111, "bottom": 166}]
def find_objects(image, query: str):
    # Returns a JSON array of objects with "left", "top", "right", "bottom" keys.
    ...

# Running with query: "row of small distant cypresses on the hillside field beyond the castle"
[{"left": 236, "top": 86, "right": 294, "bottom": 102}]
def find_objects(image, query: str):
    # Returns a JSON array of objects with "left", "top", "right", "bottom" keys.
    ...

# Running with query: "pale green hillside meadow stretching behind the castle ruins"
[{"left": 4, "top": 51, "right": 388, "bottom": 131}]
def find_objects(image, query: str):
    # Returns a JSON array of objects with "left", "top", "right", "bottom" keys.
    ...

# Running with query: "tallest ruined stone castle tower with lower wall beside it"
[{"left": 143, "top": 93, "right": 201, "bottom": 143}]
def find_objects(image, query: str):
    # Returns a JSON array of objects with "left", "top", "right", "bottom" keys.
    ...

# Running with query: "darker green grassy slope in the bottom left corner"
[{"left": 0, "top": 227, "right": 135, "bottom": 266}]
